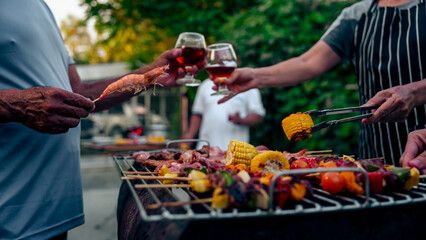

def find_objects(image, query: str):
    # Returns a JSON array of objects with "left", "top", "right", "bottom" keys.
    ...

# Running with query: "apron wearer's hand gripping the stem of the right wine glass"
[{"left": 213, "top": 68, "right": 257, "bottom": 104}]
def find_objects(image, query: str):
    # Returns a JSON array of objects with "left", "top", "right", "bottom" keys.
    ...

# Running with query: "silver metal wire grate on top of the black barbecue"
[{"left": 113, "top": 156, "right": 426, "bottom": 222}]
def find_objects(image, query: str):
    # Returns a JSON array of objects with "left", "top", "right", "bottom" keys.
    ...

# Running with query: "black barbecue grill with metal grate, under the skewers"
[{"left": 114, "top": 156, "right": 426, "bottom": 239}]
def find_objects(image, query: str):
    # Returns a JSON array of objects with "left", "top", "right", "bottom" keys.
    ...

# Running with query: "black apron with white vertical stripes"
[{"left": 353, "top": 0, "right": 426, "bottom": 165}]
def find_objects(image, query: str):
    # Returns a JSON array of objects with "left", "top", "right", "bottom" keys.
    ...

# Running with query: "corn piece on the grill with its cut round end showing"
[{"left": 250, "top": 151, "right": 290, "bottom": 173}]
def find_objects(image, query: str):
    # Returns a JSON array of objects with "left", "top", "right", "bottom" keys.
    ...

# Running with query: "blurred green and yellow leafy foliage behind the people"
[{"left": 65, "top": 0, "right": 358, "bottom": 154}]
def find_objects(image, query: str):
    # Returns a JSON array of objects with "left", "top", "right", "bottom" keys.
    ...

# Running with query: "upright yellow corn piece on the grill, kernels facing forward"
[{"left": 226, "top": 140, "right": 257, "bottom": 166}]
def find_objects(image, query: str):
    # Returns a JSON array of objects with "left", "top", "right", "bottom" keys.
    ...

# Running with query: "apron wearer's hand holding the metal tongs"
[{"left": 362, "top": 84, "right": 416, "bottom": 124}]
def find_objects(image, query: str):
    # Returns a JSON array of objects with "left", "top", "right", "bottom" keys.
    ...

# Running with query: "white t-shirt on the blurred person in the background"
[{"left": 192, "top": 79, "right": 265, "bottom": 150}]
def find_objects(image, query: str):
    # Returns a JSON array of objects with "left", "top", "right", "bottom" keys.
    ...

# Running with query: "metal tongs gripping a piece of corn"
[{"left": 305, "top": 106, "right": 379, "bottom": 133}]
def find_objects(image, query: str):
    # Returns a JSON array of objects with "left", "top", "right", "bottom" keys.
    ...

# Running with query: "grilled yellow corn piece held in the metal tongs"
[{"left": 281, "top": 112, "right": 314, "bottom": 141}]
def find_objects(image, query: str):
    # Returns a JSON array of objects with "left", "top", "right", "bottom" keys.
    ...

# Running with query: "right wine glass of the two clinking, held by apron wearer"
[{"left": 206, "top": 43, "right": 237, "bottom": 96}]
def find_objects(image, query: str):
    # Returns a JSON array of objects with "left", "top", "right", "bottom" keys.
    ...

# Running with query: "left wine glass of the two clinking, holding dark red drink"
[{"left": 175, "top": 32, "right": 206, "bottom": 87}]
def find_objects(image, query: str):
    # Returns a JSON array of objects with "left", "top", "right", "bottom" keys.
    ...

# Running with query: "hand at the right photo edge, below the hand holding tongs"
[{"left": 399, "top": 129, "right": 426, "bottom": 174}]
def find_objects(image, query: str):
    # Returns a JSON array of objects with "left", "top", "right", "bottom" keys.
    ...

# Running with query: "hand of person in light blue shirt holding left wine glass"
[{"left": 149, "top": 48, "right": 199, "bottom": 87}]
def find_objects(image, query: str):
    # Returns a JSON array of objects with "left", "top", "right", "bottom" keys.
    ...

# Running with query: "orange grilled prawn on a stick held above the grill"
[{"left": 93, "top": 65, "right": 169, "bottom": 102}]
